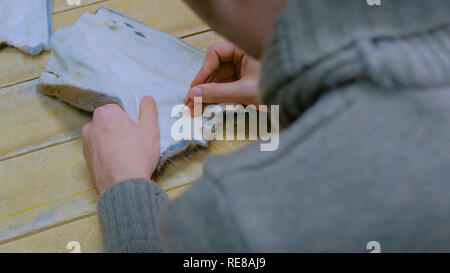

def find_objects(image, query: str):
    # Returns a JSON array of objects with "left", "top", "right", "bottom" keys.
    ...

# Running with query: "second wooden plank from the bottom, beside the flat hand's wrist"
[{"left": 0, "top": 138, "right": 246, "bottom": 244}]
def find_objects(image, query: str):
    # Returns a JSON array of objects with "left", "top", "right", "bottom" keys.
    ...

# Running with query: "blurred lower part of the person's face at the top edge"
[{"left": 184, "top": 0, "right": 288, "bottom": 59}]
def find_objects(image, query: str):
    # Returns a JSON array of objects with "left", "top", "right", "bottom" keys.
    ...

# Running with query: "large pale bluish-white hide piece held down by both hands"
[{"left": 40, "top": 7, "right": 216, "bottom": 167}]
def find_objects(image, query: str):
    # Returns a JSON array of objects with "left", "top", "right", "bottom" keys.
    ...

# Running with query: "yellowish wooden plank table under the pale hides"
[{"left": 0, "top": 0, "right": 243, "bottom": 252}]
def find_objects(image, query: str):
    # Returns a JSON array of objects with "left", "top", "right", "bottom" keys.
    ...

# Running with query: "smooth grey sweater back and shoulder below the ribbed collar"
[{"left": 163, "top": 82, "right": 450, "bottom": 251}]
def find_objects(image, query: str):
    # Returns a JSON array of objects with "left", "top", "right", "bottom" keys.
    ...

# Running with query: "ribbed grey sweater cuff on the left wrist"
[{"left": 98, "top": 179, "right": 168, "bottom": 253}]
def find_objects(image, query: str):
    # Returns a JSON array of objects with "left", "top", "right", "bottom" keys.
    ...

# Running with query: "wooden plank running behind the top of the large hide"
[{"left": 0, "top": 0, "right": 209, "bottom": 88}]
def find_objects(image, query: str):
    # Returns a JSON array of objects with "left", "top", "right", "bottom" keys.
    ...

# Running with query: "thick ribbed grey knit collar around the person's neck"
[{"left": 261, "top": 0, "right": 450, "bottom": 127}]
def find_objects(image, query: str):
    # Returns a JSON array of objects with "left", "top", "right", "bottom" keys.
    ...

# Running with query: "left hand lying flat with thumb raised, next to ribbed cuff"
[{"left": 81, "top": 97, "right": 159, "bottom": 194}]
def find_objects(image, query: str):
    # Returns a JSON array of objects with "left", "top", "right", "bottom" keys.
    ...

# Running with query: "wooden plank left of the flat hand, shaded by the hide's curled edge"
[{"left": 0, "top": 79, "right": 90, "bottom": 161}]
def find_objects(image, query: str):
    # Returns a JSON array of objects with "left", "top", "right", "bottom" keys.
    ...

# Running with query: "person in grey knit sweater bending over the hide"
[{"left": 83, "top": 0, "right": 450, "bottom": 252}]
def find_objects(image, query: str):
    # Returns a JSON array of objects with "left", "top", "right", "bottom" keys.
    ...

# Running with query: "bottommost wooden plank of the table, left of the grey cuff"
[{"left": 0, "top": 185, "right": 190, "bottom": 253}]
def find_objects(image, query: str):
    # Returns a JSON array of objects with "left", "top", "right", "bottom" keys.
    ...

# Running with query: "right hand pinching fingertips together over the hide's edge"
[{"left": 183, "top": 42, "right": 261, "bottom": 114}]
